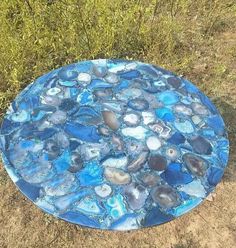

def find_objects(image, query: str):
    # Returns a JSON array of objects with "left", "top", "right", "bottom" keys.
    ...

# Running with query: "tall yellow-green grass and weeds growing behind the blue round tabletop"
[{"left": 0, "top": 0, "right": 236, "bottom": 114}]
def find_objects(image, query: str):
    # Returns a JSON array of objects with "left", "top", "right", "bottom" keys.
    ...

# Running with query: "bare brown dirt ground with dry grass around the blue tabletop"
[{"left": 0, "top": 32, "right": 236, "bottom": 248}]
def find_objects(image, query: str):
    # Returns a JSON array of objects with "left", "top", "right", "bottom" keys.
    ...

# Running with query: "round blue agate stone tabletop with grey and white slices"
[{"left": 1, "top": 60, "right": 228, "bottom": 230}]
